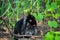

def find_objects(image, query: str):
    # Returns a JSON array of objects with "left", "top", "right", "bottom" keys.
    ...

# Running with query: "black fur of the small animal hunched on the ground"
[{"left": 14, "top": 14, "right": 37, "bottom": 40}]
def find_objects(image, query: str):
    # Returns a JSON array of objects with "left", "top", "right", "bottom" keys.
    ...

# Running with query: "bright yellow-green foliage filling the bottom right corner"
[{"left": 45, "top": 31, "right": 60, "bottom": 40}]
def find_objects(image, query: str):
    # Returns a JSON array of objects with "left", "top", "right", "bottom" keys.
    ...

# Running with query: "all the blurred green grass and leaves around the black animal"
[{"left": 0, "top": 0, "right": 60, "bottom": 40}]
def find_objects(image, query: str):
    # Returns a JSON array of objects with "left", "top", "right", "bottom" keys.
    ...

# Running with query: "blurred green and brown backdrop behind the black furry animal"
[{"left": 0, "top": 0, "right": 60, "bottom": 40}]
